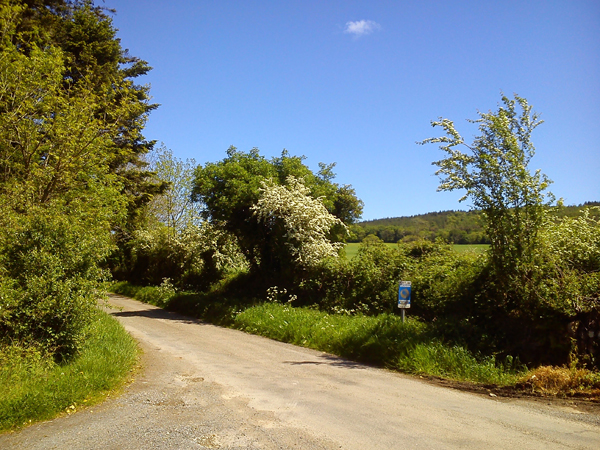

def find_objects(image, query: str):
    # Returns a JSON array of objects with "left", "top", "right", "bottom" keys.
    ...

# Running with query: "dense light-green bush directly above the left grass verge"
[{"left": 0, "top": 208, "right": 110, "bottom": 360}]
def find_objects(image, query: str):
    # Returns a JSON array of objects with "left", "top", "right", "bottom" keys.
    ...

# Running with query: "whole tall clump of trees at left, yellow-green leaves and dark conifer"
[{"left": 0, "top": 0, "right": 157, "bottom": 361}]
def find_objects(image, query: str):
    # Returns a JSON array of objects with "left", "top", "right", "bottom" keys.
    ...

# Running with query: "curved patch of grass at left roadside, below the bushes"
[{"left": 0, "top": 311, "right": 138, "bottom": 432}]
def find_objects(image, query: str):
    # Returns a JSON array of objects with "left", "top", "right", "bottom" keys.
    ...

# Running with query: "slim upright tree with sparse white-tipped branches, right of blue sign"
[{"left": 421, "top": 95, "right": 554, "bottom": 289}]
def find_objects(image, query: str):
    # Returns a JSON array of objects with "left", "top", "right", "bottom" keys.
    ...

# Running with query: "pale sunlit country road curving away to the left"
[{"left": 0, "top": 296, "right": 600, "bottom": 450}]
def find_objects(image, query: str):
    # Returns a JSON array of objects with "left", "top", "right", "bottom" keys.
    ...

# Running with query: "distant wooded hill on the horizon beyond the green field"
[{"left": 349, "top": 202, "right": 600, "bottom": 244}]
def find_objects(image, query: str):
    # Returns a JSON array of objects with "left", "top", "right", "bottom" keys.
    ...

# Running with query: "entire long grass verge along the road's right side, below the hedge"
[{"left": 111, "top": 280, "right": 600, "bottom": 399}]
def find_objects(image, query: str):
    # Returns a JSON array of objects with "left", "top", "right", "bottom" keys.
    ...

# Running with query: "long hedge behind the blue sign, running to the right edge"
[{"left": 298, "top": 236, "right": 600, "bottom": 365}]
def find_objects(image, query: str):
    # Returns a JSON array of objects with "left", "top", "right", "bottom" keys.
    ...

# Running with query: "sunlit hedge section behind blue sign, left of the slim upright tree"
[{"left": 295, "top": 238, "right": 477, "bottom": 320}]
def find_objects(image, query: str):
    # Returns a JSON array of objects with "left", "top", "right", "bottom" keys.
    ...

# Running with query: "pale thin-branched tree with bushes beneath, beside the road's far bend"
[{"left": 122, "top": 146, "right": 247, "bottom": 288}]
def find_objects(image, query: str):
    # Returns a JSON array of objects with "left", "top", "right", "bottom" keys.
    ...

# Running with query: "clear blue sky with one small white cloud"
[{"left": 105, "top": 0, "right": 600, "bottom": 220}]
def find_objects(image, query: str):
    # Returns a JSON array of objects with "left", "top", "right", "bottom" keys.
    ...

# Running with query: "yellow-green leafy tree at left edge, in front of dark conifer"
[{"left": 0, "top": 4, "right": 125, "bottom": 359}]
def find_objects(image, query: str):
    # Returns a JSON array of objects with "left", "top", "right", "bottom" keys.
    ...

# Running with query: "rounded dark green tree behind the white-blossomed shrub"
[{"left": 192, "top": 147, "right": 362, "bottom": 274}]
